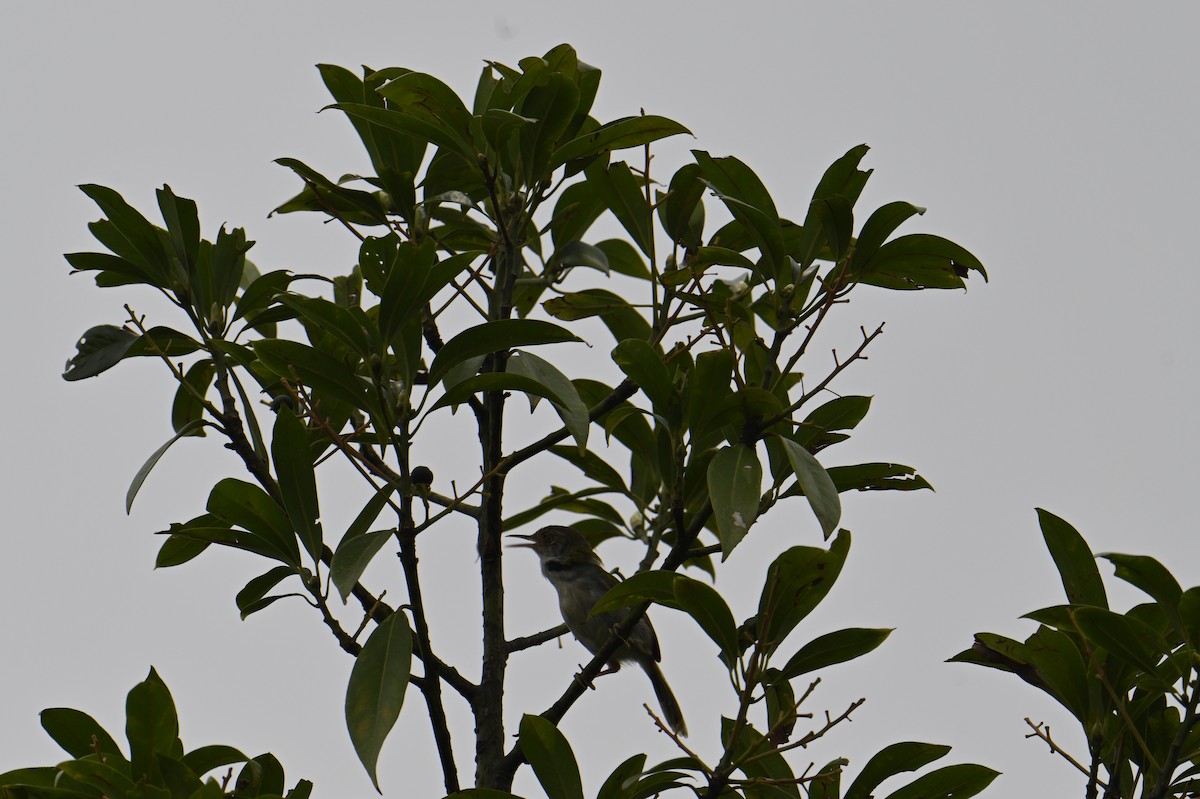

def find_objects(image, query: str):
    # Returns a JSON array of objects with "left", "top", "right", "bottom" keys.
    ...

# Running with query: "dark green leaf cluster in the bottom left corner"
[{"left": 0, "top": 668, "right": 312, "bottom": 799}]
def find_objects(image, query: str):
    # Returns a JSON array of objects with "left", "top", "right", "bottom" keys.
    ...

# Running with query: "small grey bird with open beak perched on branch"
[{"left": 511, "top": 525, "right": 688, "bottom": 735}]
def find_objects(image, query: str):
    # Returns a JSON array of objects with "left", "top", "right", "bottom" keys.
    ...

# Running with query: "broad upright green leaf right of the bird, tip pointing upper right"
[{"left": 757, "top": 530, "right": 850, "bottom": 650}]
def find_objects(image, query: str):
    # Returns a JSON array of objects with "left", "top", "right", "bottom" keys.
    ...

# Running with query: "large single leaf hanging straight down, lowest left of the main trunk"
[{"left": 346, "top": 612, "right": 413, "bottom": 793}]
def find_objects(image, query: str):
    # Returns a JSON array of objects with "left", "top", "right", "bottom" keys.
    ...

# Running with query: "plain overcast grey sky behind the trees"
[{"left": 0, "top": 0, "right": 1200, "bottom": 797}]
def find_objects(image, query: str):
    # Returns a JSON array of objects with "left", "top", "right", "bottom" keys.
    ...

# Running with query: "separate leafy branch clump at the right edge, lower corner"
[{"left": 952, "top": 510, "right": 1200, "bottom": 799}]
